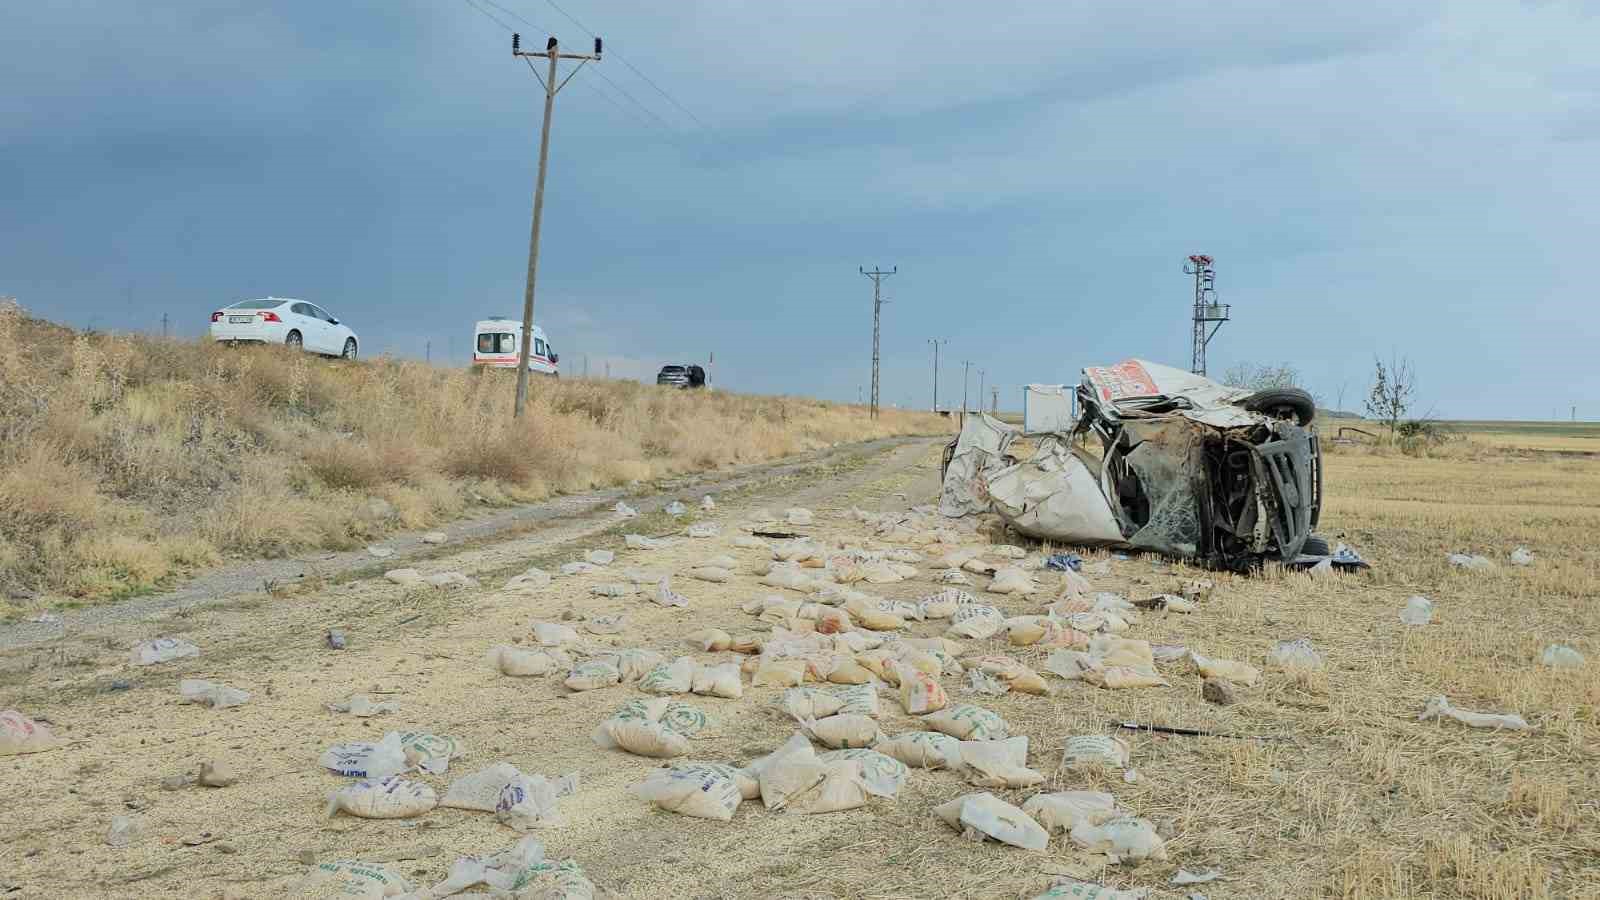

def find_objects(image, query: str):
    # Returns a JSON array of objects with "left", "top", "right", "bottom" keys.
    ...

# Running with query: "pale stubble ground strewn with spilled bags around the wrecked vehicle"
[{"left": 0, "top": 429, "right": 1600, "bottom": 900}]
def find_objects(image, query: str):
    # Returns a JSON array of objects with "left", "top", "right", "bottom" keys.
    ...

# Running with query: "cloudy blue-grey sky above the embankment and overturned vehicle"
[{"left": 0, "top": 0, "right": 1600, "bottom": 418}]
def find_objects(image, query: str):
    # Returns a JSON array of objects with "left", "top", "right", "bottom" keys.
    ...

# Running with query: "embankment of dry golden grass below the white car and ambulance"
[{"left": 0, "top": 303, "right": 949, "bottom": 605}]
